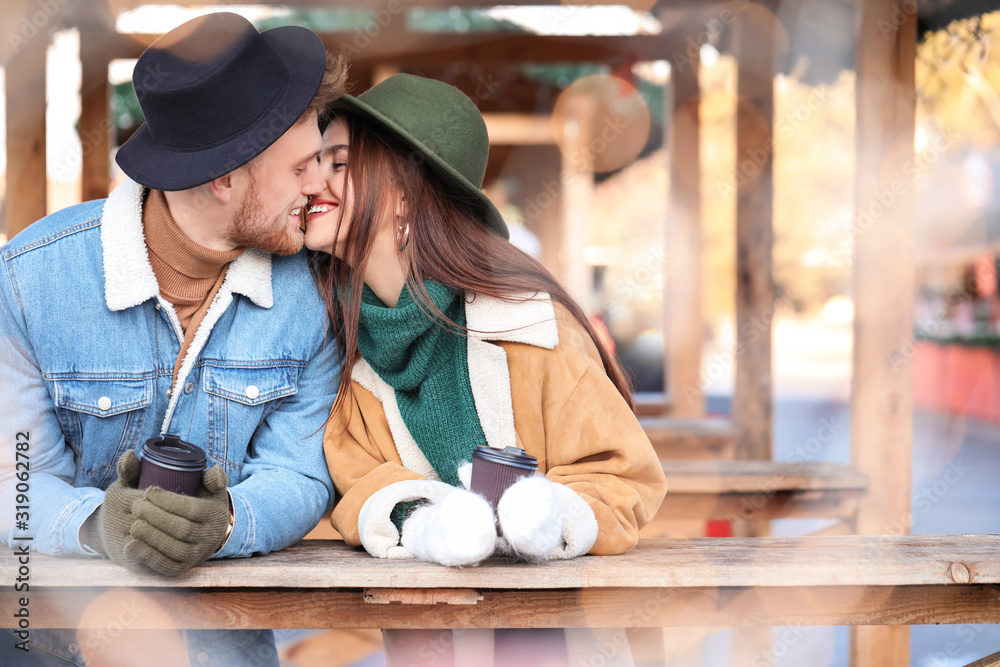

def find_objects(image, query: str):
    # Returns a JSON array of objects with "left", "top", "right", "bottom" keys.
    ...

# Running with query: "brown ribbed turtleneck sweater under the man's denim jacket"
[{"left": 142, "top": 190, "right": 243, "bottom": 383}]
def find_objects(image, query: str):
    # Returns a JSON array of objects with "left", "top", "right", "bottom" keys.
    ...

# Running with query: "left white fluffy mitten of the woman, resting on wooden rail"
[{"left": 400, "top": 487, "right": 497, "bottom": 567}]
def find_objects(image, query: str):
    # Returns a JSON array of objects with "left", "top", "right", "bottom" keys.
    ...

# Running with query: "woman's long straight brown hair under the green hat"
[{"left": 313, "top": 110, "right": 633, "bottom": 414}]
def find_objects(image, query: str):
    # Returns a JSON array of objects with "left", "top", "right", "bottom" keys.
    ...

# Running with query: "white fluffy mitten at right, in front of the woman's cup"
[{"left": 497, "top": 475, "right": 597, "bottom": 561}]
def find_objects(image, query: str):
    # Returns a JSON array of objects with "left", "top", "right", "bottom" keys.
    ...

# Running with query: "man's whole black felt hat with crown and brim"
[{"left": 115, "top": 12, "right": 326, "bottom": 191}]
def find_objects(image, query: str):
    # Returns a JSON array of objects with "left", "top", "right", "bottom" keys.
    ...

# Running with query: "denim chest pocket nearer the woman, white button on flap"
[{"left": 202, "top": 364, "right": 299, "bottom": 470}]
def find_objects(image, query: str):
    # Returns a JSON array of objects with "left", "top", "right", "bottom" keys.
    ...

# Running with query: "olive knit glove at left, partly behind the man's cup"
[{"left": 91, "top": 449, "right": 144, "bottom": 572}]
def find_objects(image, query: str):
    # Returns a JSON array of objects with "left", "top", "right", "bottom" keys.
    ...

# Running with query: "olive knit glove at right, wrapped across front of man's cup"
[{"left": 124, "top": 466, "right": 229, "bottom": 576}]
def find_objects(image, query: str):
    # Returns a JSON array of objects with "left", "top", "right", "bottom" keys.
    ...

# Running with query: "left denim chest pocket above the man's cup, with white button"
[{"left": 54, "top": 378, "right": 153, "bottom": 489}]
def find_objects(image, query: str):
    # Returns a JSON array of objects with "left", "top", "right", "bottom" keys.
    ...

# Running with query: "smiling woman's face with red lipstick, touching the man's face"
[{"left": 305, "top": 118, "right": 352, "bottom": 257}]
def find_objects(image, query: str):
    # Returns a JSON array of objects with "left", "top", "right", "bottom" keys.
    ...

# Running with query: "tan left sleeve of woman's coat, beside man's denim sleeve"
[{"left": 323, "top": 383, "right": 423, "bottom": 546}]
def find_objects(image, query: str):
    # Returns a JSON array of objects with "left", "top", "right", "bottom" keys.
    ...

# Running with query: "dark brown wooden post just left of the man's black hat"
[{"left": 79, "top": 28, "right": 114, "bottom": 201}]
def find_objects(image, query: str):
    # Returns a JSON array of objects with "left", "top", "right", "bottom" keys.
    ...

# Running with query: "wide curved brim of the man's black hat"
[{"left": 115, "top": 26, "right": 326, "bottom": 191}]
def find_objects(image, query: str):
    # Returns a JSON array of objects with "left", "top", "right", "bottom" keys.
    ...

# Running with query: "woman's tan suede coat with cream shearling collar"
[{"left": 324, "top": 294, "right": 666, "bottom": 554}]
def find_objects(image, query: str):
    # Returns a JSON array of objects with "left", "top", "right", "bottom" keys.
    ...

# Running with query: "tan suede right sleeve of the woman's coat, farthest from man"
[{"left": 508, "top": 314, "right": 666, "bottom": 554}]
